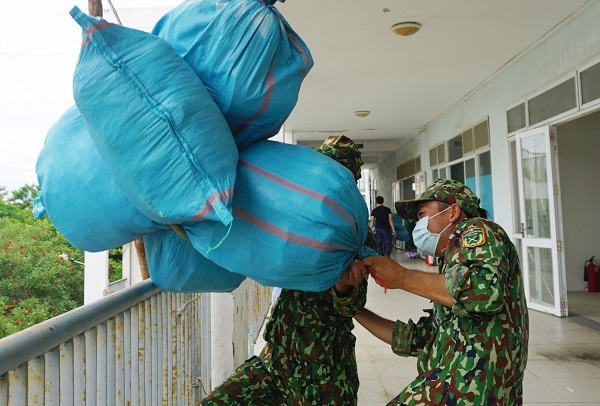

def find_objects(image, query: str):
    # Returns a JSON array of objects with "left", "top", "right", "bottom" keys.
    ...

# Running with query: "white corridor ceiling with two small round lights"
[{"left": 276, "top": 0, "right": 597, "bottom": 168}]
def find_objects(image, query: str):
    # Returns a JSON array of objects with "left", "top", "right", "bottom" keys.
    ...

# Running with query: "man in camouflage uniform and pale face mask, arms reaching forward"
[{"left": 356, "top": 179, "right": 529, "bottom": 405}]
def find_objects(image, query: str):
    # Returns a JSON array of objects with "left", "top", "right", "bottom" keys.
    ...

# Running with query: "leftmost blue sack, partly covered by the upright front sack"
[{"left": 33, "top": 106, "right": 165, "bottom": 252}]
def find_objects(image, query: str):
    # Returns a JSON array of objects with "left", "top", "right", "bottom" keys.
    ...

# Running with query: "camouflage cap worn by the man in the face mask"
[{"left": 394, "top": 179, "right": 481, "bottom": 221}]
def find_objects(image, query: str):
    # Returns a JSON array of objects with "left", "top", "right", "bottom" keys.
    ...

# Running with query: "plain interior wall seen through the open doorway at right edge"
[{"left": 558, "top": 112, "right": 600, "bottom": 291}]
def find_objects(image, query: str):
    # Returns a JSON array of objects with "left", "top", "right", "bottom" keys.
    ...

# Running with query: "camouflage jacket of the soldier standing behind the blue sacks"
[{"left": 261, "top": 279, "right": 367, "bottom": 380}]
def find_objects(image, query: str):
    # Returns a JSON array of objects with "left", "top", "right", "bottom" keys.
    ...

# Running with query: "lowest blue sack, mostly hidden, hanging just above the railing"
[{"left": 144, "top": 230, "right": 246, "bottom": 292}]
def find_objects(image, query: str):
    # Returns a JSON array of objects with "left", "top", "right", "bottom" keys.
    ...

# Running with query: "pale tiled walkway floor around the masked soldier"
[{"left": 354, "top": 251, "right": 600, "bottom": 406}]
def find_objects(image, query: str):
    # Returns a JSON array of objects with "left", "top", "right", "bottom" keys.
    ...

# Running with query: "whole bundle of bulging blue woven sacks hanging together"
[{"left": 34, "top": 0, "right": 368, "bottom": 292}]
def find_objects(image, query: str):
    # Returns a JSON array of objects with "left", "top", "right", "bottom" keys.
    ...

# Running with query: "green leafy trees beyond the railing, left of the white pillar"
[{"left": 0, "top": 197, "right": 84, "bottom": 338}]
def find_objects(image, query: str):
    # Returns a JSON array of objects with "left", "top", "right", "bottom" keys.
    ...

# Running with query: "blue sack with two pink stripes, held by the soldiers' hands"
[{"left": 183, "top": 141, "right": 368, "bottom": 291}]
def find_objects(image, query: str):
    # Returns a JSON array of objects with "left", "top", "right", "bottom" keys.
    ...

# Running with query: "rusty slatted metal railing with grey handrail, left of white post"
[{"left": 0, "top": 280, "right": 210, "bottom": 406}]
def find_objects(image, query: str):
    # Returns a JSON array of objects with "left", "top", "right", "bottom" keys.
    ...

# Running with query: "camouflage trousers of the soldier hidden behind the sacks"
[{"left": 200, "top": 357, "right": 358, "bottom": 406}]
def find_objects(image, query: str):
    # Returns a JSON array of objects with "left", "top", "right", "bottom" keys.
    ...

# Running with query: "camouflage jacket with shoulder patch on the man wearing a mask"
[{"left": 392, "top": 218, "right": 529, "bottom": 405}]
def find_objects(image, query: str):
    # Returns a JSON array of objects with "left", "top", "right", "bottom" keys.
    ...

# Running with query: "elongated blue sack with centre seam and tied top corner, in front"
[{"left": 71, "top": 7, "right": 238, "bottom": 224}]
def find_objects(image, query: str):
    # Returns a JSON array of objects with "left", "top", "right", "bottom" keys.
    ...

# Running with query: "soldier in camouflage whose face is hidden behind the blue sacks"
[{"left": 200, "top": 136, "right": 376, "bottom": 406}]
